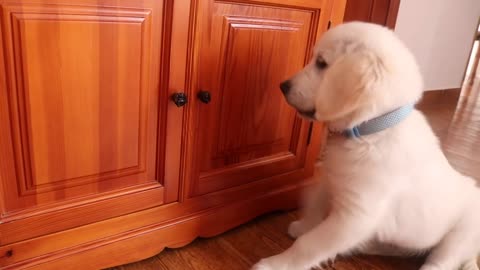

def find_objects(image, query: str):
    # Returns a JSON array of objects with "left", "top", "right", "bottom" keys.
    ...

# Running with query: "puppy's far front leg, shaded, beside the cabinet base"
[{"left": 288, "top": 181, "right": 330, "bottom": 239}]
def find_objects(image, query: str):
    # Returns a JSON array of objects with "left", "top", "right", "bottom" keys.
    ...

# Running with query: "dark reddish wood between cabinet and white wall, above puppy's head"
[{"left": 344, "top": 0, "right": 400, "bottom": 29}]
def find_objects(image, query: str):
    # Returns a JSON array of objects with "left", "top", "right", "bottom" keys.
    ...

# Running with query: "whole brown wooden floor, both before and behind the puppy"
[{"left": 109, "top": 80, "right": 480, "bottom": 270}]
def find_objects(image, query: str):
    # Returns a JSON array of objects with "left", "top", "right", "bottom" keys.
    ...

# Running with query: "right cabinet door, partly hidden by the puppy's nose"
[{"left": 188, "top": 0, "right": 332, "bottom": 196}]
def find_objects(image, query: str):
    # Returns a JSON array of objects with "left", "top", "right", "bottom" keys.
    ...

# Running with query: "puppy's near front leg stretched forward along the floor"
[{"left": 253, "top": 211, "right": 379, "bottom": 270}]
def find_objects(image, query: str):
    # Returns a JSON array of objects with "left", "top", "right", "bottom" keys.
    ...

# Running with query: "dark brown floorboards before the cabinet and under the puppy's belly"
[{"left": 110, "top": 212, "right": 423, "bottom": 270}]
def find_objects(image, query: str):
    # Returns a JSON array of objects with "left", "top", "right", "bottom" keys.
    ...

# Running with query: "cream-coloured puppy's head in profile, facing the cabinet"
[{"left": 280, "top": 22, "right": 423, "bottom": 130}]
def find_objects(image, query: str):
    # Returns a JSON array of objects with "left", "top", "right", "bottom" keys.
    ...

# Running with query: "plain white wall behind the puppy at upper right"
[{"left": 395, "top": 0, "right": 480, "bottom": 90}]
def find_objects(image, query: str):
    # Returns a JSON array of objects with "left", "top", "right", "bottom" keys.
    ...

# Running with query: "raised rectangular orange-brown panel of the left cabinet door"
[{"left": 13, "top": 13, "right": 144, "bottom": 194}]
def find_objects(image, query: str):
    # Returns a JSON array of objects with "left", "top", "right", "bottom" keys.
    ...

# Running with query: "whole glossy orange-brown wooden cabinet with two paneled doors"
[{"left": 0, "top": 0, "right": 345, "bottom": 269}]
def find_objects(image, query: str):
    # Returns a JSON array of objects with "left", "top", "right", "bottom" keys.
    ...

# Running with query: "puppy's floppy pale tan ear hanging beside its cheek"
[{"left": 316, "top": 49, "right": 383, "bottom": 123}]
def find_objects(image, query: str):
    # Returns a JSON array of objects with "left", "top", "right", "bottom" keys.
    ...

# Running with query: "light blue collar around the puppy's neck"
[{"left": 343, "top": 104, "right": 414, "bottom": 138}]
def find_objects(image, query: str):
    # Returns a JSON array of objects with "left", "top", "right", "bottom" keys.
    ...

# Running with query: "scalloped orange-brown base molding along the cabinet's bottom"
[{"left": 0, "top": 182, "right": 307, "bottom": 270}]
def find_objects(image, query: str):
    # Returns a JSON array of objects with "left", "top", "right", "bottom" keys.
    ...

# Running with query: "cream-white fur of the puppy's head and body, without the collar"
[{"left": 253, "top": 22, "right": 480, "bottom": 270}]
